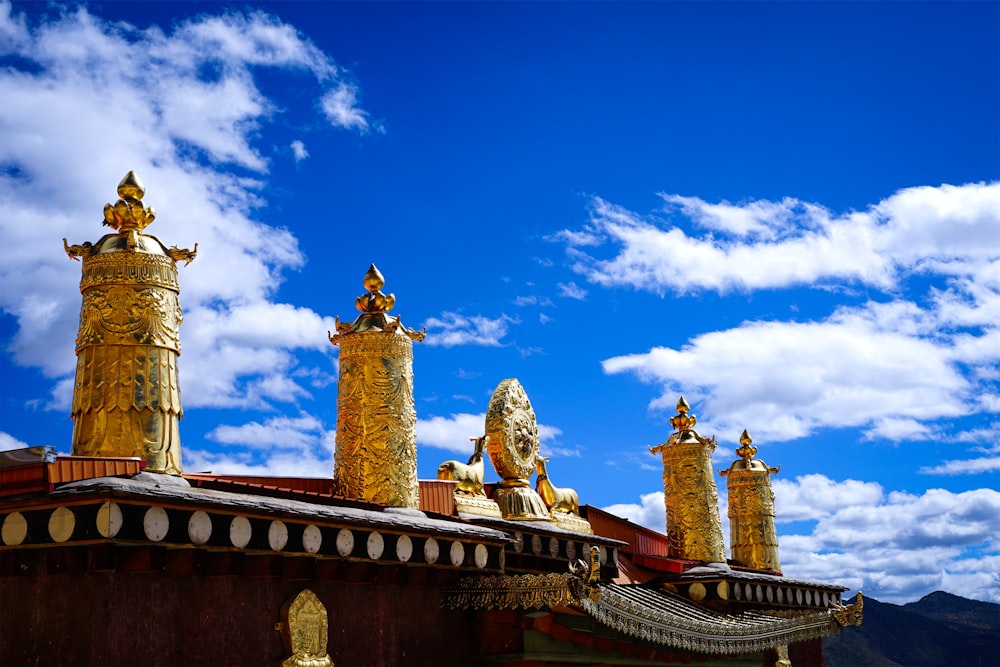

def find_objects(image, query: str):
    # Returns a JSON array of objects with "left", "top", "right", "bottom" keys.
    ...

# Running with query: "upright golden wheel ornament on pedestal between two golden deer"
[{"left": 486, "top": 378, "right": 552, "bottom": 521}]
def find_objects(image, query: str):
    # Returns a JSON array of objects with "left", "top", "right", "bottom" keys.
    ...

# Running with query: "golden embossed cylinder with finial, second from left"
[{"left": 328, "top": 264, "right": 425, "bottom": 508}]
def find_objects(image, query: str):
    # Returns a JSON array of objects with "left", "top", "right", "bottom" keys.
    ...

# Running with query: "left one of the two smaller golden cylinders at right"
[{"left": 649, "top": 396, "right": 726, "bottom": 563}]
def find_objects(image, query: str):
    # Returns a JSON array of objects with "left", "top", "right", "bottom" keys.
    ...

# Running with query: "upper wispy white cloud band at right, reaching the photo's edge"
[{"left": 554, "top": 183, "right": 1000, "bottom": 293}]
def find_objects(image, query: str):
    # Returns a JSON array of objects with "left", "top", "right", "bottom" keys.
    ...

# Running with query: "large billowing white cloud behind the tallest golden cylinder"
[{"left": 0, "top": 3, "right": 368, "bottom": 407}]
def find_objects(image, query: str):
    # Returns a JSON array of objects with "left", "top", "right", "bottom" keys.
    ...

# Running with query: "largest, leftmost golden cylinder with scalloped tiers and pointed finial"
[{"left": 63, "top": 171, "right": 198, "bottom": 475}]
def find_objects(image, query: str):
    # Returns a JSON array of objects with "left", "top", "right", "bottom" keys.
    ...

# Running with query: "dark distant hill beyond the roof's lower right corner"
[{"left": 823, "top": 591, "right": 1000, "bottom": 667}]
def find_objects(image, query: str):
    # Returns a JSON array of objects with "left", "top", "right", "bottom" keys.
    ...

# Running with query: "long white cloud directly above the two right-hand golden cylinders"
[{"left": 603, "top": 308, "right": 973, "bottom": 441}]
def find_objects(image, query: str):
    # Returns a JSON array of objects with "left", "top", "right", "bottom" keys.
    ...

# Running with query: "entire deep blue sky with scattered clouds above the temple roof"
[{"left": 0, "top": 2, "right": 1000, "bottom": 602}]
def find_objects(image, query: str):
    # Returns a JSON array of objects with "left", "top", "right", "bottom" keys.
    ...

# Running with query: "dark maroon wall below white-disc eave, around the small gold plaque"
[{"left": 0, "top": 572, "right": 471, "bottom": 667}]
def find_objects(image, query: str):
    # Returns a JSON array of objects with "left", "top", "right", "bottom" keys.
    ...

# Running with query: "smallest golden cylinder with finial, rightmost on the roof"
[{"left": 719, "top": 429, "right": 781, "bottom": 572}]
